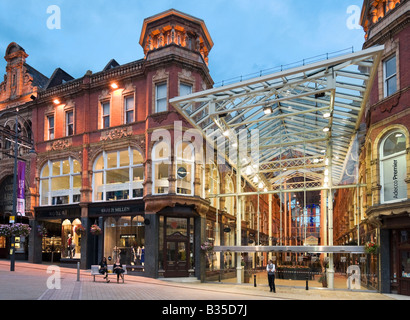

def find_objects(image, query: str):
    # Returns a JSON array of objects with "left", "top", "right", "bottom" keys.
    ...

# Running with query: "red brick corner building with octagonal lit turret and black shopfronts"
[{"left": 8, "top": 10, "right": 279, "bottom": 278}]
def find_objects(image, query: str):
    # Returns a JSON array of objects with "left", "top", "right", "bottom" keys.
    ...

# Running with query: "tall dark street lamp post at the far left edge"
[{"left": 0, "top": 108, "right": 35, "bottom": 271}]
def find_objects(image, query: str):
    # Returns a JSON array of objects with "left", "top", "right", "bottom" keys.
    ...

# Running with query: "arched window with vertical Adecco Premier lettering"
[{"left": 380, "top": 131, "right": 407, "bottom": 203}]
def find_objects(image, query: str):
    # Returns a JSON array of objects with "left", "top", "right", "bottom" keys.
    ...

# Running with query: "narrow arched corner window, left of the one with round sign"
[{"left": 152, "top": 141, "right": 171, "bottom": 194}]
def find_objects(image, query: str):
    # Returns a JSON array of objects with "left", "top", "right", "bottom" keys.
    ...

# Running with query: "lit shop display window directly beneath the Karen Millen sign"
[{"left": 104, "top": 216, "right": 145, "bottom": 267}]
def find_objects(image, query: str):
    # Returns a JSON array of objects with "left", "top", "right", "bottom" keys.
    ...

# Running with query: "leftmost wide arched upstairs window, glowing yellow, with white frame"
[{"left": 40, "top": 157, "right": 81, "bottom": 206}]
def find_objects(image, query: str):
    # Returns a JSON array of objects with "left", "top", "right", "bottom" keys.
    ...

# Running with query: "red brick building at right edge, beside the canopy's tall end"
[{"left": 335, "top": 0, "right": 410, "bottom": 295}]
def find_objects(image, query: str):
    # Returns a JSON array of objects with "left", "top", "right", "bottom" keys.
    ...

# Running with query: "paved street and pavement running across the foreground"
[{"left": 0, "top": 260, "right": 410, "bottom": 306}]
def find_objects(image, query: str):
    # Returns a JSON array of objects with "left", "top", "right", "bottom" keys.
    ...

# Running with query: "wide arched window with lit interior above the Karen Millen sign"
[{"left": 93, "top": 147, "right": 144, "bottom": 201}]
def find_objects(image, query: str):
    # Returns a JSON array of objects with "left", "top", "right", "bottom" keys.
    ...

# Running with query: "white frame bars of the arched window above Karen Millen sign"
[{"left": 93, "top": 147, "right": 145, "bottom": 202}]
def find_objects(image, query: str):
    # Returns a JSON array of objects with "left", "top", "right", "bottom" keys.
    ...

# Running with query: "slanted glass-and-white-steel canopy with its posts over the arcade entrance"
[{"left": 170, "top": 46, "right": 384, "bottom": 287}]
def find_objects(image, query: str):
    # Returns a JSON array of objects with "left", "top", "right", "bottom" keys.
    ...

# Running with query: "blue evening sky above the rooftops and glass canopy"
[{"left": 0, "top": 0, "right": 364, "bottom": 82}]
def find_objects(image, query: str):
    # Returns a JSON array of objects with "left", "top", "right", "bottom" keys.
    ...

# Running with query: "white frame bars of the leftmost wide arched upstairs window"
[{"left": 39, "top": 157, "right": 81, "bottom": 206}]
